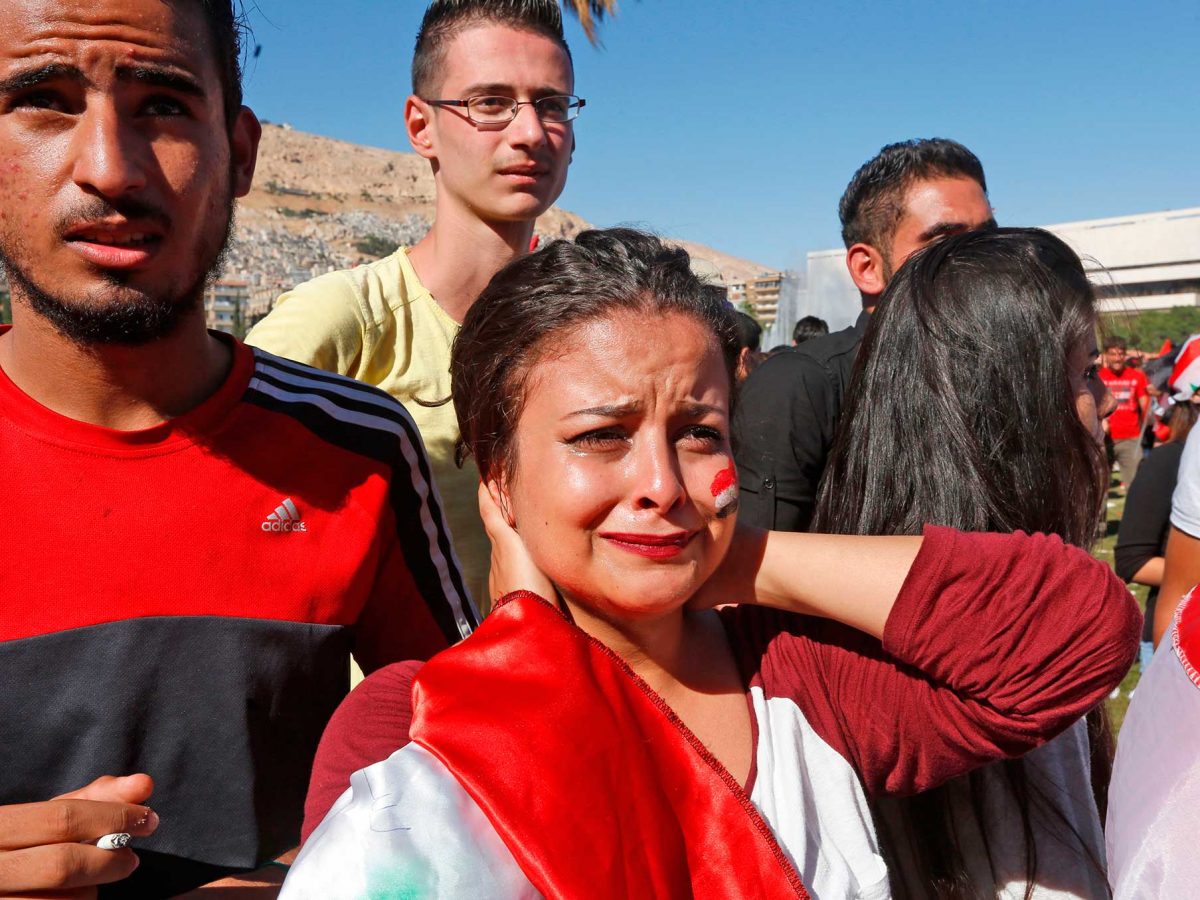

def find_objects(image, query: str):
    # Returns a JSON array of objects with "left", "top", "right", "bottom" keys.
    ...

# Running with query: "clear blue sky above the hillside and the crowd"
[{"left": 246, "top": 0, "right": 1200, "bottom": 268}]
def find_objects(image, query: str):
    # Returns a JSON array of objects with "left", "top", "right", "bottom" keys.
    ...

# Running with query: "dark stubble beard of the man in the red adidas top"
[{"left": 0, "top": 190, "right": 234, "bottom": 347}]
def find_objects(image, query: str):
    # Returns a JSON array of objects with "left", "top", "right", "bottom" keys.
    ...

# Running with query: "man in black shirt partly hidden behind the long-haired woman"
[{"left": 733, "top": 138, "right": 996, "bottom": 532}]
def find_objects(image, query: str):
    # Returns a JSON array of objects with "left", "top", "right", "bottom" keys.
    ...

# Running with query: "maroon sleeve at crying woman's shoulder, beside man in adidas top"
[{"left": 300, "top": 661, "right": 424, "bottom": 842}]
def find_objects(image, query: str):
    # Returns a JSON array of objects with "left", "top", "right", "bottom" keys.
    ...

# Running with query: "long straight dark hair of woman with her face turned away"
[{"left": 812, "top": 228, "right": 1112, "bottom": 898}]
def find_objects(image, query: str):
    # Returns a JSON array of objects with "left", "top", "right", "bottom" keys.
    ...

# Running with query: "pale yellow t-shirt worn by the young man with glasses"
[{"left": 246, "top": 247, "right": 492, "bottom": 612}]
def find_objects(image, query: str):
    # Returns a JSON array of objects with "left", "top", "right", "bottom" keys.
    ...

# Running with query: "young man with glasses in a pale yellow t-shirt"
[{"left": 247, "top": 0, "right": 583, "bottom": 608}]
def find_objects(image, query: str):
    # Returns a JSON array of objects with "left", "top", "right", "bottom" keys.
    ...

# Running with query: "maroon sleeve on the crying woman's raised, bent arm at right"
[{"left": 739, "top": 527, "right": 1141, "bottom": 794}]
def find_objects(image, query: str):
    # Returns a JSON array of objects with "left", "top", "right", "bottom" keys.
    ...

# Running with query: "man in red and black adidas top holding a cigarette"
[{"left": 0, "top": 0, "right": 475, "bottom": 896}]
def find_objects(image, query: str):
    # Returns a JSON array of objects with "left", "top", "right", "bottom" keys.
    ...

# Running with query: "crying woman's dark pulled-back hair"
[{"left": 450, "top": 228, "right": 738, "bottom": 487}]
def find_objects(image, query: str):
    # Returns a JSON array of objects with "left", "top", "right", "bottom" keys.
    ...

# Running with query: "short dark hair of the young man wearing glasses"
[{"left": 413, "top": 0, "right": 571, "bottom": 100}]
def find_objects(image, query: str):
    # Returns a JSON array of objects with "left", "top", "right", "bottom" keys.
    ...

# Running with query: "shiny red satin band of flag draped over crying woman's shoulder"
[{"left": 412, "top": 593, "right": 808, "bottom": 900}]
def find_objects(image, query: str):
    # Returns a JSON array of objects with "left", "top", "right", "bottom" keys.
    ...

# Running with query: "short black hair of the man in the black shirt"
[{"left": 838, "top": 138, "right": 988, "bottom": 250}]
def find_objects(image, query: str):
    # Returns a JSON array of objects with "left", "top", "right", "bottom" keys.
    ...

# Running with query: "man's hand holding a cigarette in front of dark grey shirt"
[{"left": 0, "top": 775, "right": 158, "bottom": 898}]
